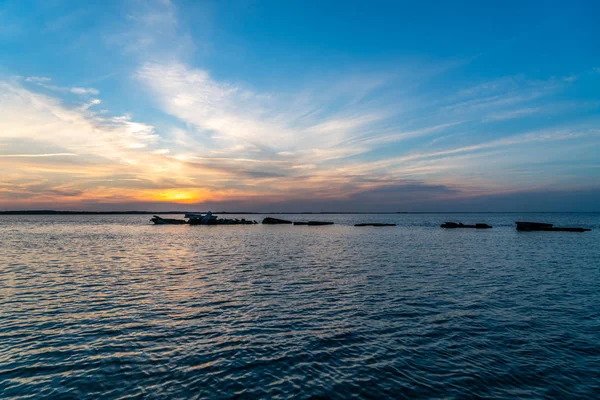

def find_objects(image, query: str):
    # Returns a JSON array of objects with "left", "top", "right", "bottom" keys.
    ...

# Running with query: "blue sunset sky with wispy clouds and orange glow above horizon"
[{"left": 0, "top": 0, "right": 600, "bottom": 212}]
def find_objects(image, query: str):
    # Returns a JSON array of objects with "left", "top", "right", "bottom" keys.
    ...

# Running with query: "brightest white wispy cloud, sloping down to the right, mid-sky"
[{"left": 136, "top": 63, "right": 387, "bottom": 159}]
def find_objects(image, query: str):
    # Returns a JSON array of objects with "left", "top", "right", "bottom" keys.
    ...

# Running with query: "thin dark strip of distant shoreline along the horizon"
[{"left": 0, "top": 210, "right": 600, "bottom": 215}]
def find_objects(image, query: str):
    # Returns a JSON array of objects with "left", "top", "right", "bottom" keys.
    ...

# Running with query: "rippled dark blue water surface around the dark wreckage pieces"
[{"left": 0, "top": 214, "right": 600, "bottom": 399}]
